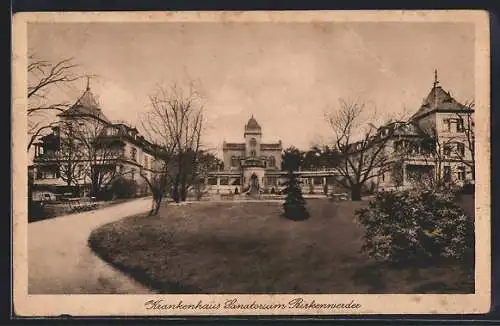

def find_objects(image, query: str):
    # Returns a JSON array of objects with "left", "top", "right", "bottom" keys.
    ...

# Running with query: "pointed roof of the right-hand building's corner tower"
[{"left": 411, "top": 85, "right": 469, "bottom": 119}]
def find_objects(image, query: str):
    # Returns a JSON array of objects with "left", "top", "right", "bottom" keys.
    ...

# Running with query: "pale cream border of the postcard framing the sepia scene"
[{"left": 12, "top": 10, "right": 491, "bottom": 316}]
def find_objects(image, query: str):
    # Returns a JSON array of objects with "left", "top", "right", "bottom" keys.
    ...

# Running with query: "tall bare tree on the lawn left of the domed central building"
[{"left": 142, "top": 85, "right": 204, "bottom": 206}]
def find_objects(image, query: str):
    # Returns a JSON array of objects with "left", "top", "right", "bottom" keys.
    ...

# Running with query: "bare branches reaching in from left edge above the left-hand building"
[{"left": 27, "top": 54, "right": 83, "bottom": 151}]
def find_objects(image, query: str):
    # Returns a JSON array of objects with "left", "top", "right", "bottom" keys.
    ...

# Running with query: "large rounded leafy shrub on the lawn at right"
[{"left": 356, "top": 190, "right": 474, "bottom": 263}]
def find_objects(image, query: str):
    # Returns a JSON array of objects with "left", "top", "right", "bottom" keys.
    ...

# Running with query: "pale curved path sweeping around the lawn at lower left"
[{"left": 28, "top": 198, "right": 153, "bottom": 294}]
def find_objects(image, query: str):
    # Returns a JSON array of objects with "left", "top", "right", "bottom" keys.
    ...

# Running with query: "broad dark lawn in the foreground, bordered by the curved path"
[{"left": 89, "top": 199, "right": 474, "bottom": 294}]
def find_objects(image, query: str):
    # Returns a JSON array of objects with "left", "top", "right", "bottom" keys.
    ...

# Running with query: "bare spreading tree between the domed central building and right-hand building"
[{"left": 326, "top": 99, "right": 402, "bottom": 201}]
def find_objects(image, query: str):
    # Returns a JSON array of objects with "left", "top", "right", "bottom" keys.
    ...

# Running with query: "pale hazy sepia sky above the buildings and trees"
[{"left": 28, "top": 22, "right": 474, "bottom": 157}]
